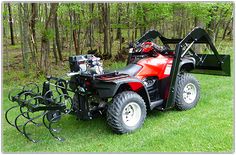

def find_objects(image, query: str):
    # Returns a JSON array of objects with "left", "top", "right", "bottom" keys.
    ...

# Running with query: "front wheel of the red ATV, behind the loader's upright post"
[{"left": 175, "top": 73, "right": 200, "bottom": 110}]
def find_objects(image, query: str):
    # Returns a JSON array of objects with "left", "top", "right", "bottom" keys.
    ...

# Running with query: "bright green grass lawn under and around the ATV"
[{"left": 2, "top": 41, "right": 234, "bottom": 153}]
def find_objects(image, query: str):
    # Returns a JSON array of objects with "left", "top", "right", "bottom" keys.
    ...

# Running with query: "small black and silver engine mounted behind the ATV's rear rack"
[{"left": 69, "top": 54, "right": 104, "bottom": 75}]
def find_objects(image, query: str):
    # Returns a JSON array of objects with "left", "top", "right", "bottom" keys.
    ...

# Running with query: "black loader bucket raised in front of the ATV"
[{"left": 191, "top": 54, "right": 230, "bottom": 76}]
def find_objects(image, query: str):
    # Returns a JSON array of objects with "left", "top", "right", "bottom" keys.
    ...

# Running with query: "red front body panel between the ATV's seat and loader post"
[{"left": 135, "top": 54, "right": 173, "bottom": 80}]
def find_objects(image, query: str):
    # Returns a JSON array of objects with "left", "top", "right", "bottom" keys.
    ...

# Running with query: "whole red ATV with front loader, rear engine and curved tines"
[{"left": 6, "top": 28, "right": 230, "bottom": 141}]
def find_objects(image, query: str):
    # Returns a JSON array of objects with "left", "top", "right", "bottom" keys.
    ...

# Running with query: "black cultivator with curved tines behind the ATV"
[{"left": 5, "top": 77, "right": 72, "bottom": 142}]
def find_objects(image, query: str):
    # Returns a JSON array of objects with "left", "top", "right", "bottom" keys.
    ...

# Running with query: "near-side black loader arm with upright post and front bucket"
[{"left": 164, "top": 27, "right": 230, "bottom": 108}]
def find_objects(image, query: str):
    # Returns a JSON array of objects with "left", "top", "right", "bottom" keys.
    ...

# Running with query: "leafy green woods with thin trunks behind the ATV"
[{"left": 2, "top": 2, "right": 233, "bottom": 75}]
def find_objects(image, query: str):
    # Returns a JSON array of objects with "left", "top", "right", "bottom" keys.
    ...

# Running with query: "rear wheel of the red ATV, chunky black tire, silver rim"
[{"left": 107, "top": 91, "right": 146, "bottom": 133}]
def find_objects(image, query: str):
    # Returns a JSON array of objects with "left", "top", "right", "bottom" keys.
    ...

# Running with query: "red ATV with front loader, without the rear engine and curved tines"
[{"left": 67, "top": 28, "right": 230, "bottom": 133}]
